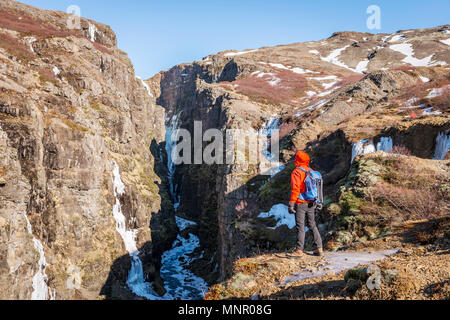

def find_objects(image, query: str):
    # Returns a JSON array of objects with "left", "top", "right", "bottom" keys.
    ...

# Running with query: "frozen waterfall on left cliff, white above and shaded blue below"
[{"left": 113, "top": 162, "right": 161, "bottom": 300}]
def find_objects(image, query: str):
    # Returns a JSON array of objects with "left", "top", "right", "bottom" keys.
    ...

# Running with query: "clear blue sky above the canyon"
[{"left": 21, "top": 0, "right": 450, "bottom": 79}]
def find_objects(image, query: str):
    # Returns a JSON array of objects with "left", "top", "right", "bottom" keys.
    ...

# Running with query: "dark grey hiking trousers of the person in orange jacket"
[{"left": 295, "top": 203, "right": 322, "bottom": 251}]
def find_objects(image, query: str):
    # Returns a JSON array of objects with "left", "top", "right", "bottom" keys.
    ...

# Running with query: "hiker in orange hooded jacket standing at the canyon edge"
[{"left": 289, "top": 151, "right": 323, "bottom": 257}]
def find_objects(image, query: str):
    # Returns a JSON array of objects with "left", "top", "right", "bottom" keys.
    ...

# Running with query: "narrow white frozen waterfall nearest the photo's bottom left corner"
[{"left": 23, "top": 213, "right": 55, "bottom": 300}]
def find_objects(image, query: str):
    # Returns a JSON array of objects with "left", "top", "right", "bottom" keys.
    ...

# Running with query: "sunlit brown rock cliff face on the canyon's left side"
[{"left": 0, "top": 1, "right": 175, "bottom": 299}]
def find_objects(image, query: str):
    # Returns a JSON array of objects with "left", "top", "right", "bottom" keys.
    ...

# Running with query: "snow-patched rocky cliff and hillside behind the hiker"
[{"left": 152, "top": 26, "right": 450, "bottom": 279}]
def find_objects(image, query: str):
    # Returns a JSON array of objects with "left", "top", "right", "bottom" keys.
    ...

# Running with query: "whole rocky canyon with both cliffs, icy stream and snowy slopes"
[{"left": 0, "top": 0, "right": 450, "bottom": 300}]
